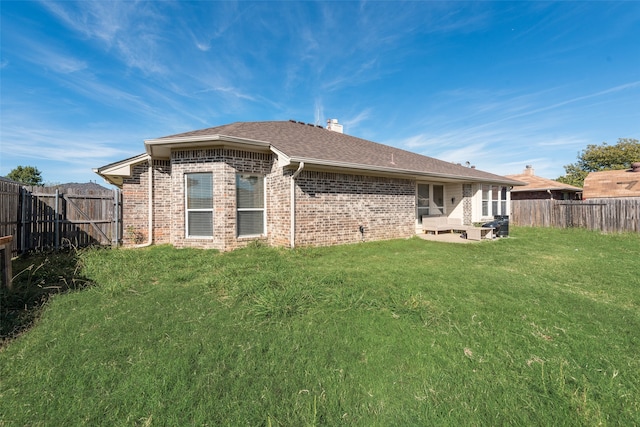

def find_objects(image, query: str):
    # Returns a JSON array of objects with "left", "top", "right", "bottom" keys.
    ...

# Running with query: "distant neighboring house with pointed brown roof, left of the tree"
[{"left": 505, "top": 165, "right": 582, "bottom": 200}]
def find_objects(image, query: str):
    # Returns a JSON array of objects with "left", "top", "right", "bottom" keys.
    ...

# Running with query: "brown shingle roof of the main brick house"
[{"left": 150, "top": 121, "right": 521, "bottom": 185}]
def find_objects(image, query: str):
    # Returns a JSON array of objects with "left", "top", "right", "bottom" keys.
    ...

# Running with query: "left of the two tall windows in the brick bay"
[{"left": 184, "top": 173, "right": 213, "bottom": 237}]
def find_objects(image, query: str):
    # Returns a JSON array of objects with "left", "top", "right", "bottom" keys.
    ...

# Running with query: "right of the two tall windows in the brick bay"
[{"left": 236, "top": 174, "right": 265, "bottom": 237}]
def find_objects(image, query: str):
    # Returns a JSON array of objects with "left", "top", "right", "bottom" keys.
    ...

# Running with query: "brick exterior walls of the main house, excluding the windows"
[{"left": 122, "top": 148, "right": 415, "bottom": 250}]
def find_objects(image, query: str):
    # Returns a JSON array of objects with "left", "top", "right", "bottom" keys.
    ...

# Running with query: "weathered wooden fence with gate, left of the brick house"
[{"left": 0, "top": 179, "right": 122, "bottom": 254}]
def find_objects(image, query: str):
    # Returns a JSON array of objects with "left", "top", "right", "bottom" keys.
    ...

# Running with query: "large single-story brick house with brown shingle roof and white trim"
[{"left": 94, "top": 120, "right": 522, "bottom": 251}]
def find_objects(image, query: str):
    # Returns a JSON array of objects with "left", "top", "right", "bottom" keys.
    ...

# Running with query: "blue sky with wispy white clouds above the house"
[{"left": 0, "top": 1, "right": 640, "bottom": 183}]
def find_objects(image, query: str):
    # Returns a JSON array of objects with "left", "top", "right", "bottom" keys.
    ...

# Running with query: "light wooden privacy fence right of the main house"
[{"left": 510, "top": 198, "right": 640, "bottom": 233}]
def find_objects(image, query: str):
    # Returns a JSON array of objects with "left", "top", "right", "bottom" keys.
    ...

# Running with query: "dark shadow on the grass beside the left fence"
[{"left": 0, "top": 248, "right": 91, "bottom": 347}]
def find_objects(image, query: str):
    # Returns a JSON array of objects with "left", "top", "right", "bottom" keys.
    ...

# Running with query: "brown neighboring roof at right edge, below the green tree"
[{"left": 582, "top": 163, "right": 640, "bottom": 199}]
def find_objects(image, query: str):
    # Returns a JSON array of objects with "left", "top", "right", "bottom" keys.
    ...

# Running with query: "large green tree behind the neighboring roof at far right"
[{"left": 556, "top": 138, "right": 640, "bottom": 187}]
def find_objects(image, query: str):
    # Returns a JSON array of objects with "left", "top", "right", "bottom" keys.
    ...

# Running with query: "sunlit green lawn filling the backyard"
[{"left": 0, "top": 228, "right": 640, "bottom": 426}]
